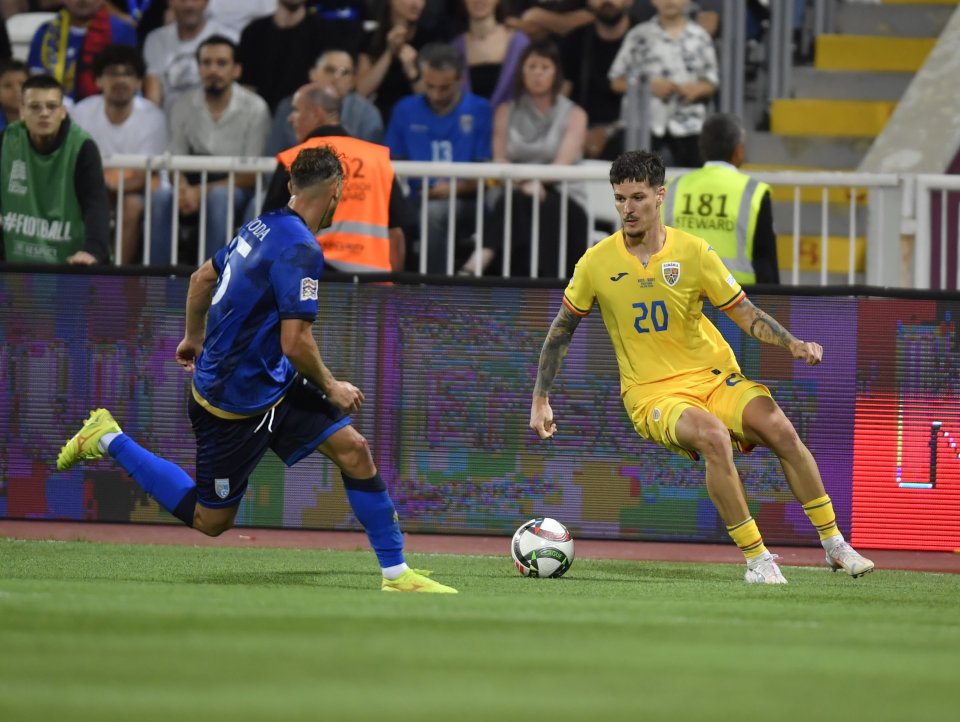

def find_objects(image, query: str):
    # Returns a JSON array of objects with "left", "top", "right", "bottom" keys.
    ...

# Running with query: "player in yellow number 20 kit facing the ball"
[{"left": 530, "top": 151, "right": 873, "bottom": 584}]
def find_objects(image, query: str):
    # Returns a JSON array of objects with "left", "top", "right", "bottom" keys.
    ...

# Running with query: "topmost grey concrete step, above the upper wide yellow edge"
[{"left": 836, "top": 3, "right": 956, "bottom": 38}]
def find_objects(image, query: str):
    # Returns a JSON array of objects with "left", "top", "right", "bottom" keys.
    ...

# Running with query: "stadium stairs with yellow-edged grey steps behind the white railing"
[{"left": 744, "top": 0, "right": 960, "bottom": 275}]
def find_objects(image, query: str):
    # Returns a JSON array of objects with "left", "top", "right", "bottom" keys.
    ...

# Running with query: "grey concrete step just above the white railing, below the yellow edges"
[{"left": 747, "top": 132, "right": 872, "bottom": 170}]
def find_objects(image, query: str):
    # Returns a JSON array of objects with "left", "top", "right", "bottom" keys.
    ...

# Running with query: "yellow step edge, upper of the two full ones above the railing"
[{"left": 813, "top": 35, "right": 937, "bottom": 73}]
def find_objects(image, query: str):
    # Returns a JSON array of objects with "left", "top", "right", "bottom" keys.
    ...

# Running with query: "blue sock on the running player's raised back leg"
[{"left": 107, "top": 434, "right": 197, "bottom": 527}]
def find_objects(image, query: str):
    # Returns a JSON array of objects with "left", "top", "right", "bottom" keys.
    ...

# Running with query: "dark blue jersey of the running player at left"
[{"left": 193, "top": 208, "right": 323, "bottom": 418}]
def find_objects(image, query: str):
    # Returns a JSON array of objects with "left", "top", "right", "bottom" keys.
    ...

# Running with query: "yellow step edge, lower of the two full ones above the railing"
[{"left": 770, "top": 98, "right": 897, "bottom": 138}]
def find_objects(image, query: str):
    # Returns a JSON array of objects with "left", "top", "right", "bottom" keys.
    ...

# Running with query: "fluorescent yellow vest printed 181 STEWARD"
[{"left": 663, "top": 165, "right": 770, "bottom": 283}]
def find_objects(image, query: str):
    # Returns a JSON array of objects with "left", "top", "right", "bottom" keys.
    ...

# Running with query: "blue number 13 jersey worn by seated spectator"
[{"left": 384, "top": 93, "right": 493, "bottom": 195}]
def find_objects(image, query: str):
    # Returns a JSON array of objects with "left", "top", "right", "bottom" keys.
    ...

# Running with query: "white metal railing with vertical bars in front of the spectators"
[{"left": 104, "top": 155, "right": 960, "bottom": 288}]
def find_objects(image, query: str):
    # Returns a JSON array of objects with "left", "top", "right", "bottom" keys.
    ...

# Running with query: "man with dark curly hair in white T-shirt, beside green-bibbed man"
[{"left": 70, "top": 45, "right": 167, "bottom": 264}]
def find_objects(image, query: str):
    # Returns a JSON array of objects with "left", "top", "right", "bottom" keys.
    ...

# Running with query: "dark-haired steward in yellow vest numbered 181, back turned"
[{"left": 663, "top": 113, "right": 780, "bottom": 284}]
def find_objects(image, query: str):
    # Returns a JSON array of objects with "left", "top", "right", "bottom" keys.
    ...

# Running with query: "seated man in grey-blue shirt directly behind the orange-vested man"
[{"left": 267, "top": 50, "right": 383, "bottom": 155}]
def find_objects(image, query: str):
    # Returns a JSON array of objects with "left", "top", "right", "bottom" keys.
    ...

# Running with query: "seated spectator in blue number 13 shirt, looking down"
[{"left": 386, "top": 43, "right": 493, "bottom": 273}]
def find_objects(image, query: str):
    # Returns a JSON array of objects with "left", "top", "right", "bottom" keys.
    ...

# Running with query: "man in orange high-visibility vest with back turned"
[{"left": 264, "top": 83, "right": 407, "bottom": 273}]
